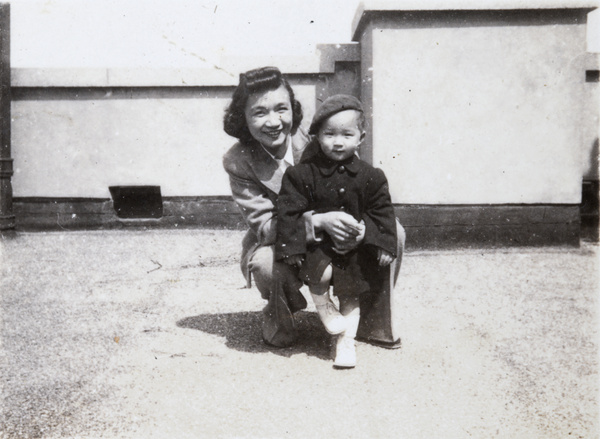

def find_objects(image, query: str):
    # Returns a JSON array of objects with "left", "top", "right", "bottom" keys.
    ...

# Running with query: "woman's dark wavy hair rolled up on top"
[{"left": 223, "top": 67, "right": 302, "bottom": 143}]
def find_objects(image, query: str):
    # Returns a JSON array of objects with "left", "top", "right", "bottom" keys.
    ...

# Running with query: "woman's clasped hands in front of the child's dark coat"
[{"left": 312, "top": 211, "right": 365, "bottom": 250}]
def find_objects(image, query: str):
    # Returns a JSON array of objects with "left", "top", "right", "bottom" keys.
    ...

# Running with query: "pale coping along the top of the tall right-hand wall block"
[{"left": 351, "top": 0, "right": 600, "bottom": 41}]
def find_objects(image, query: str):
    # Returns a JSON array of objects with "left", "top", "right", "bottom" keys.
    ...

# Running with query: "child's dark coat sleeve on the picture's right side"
[{"left": 363, "top": 168, "right": 397, "bottom": 257}]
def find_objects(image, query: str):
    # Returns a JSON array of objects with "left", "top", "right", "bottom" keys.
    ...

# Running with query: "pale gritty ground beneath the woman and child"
[{"left": 0, "top": 230, "right": 600, "bottom": 439}]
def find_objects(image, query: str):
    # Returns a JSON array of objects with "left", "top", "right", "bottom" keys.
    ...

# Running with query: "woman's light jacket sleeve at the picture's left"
[{"left": 223, "top": 148, "right": 276, "bottom": 246}]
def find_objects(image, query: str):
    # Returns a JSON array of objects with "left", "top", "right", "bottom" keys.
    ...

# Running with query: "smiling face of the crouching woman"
[{"left": 245, "top": 85, "right": 293, "bottom": 149}]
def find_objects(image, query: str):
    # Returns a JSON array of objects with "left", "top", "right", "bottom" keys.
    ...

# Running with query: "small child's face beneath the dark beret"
[{"left": 317, "top": 110, "right": 365, "bottom": 162}]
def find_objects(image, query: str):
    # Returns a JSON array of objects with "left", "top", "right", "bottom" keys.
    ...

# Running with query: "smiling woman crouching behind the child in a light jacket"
[{"left": 223, "top": 67, "right": 404, "bottom": 347}]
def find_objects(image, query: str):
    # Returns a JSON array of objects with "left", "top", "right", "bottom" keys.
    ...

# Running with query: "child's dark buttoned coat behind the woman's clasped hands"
[{"left": 275, "top": 147, "right": 397, "bottom": 295}]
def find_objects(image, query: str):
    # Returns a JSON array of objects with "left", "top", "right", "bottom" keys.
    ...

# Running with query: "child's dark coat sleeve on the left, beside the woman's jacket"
[{"left": 275, "top": 166, "right": 309, "bottom": 260}]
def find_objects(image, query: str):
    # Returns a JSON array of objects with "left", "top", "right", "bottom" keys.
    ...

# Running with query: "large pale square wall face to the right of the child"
[{"left": 372, "top": 25, "right": 585, "bottom": 204}]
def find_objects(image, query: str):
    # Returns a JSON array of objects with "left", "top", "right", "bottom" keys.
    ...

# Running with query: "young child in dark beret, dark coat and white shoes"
[{"left": 275, "top": 95, "right": 397, "bottom": 368}]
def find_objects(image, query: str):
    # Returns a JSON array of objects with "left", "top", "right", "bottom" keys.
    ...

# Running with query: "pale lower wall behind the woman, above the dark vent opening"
[{"left": 12, "top": 86, "right": 315, "bottom": 198}]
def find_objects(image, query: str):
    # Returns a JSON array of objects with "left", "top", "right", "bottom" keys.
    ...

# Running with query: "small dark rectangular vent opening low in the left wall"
[{"left": 108, "top": 186, "right": 163, "bottom": 218}]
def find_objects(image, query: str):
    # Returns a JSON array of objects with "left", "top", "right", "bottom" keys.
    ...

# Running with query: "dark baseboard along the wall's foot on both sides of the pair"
[{"left": 13, "top": 196, "right": 581, "bottom": 250}]
